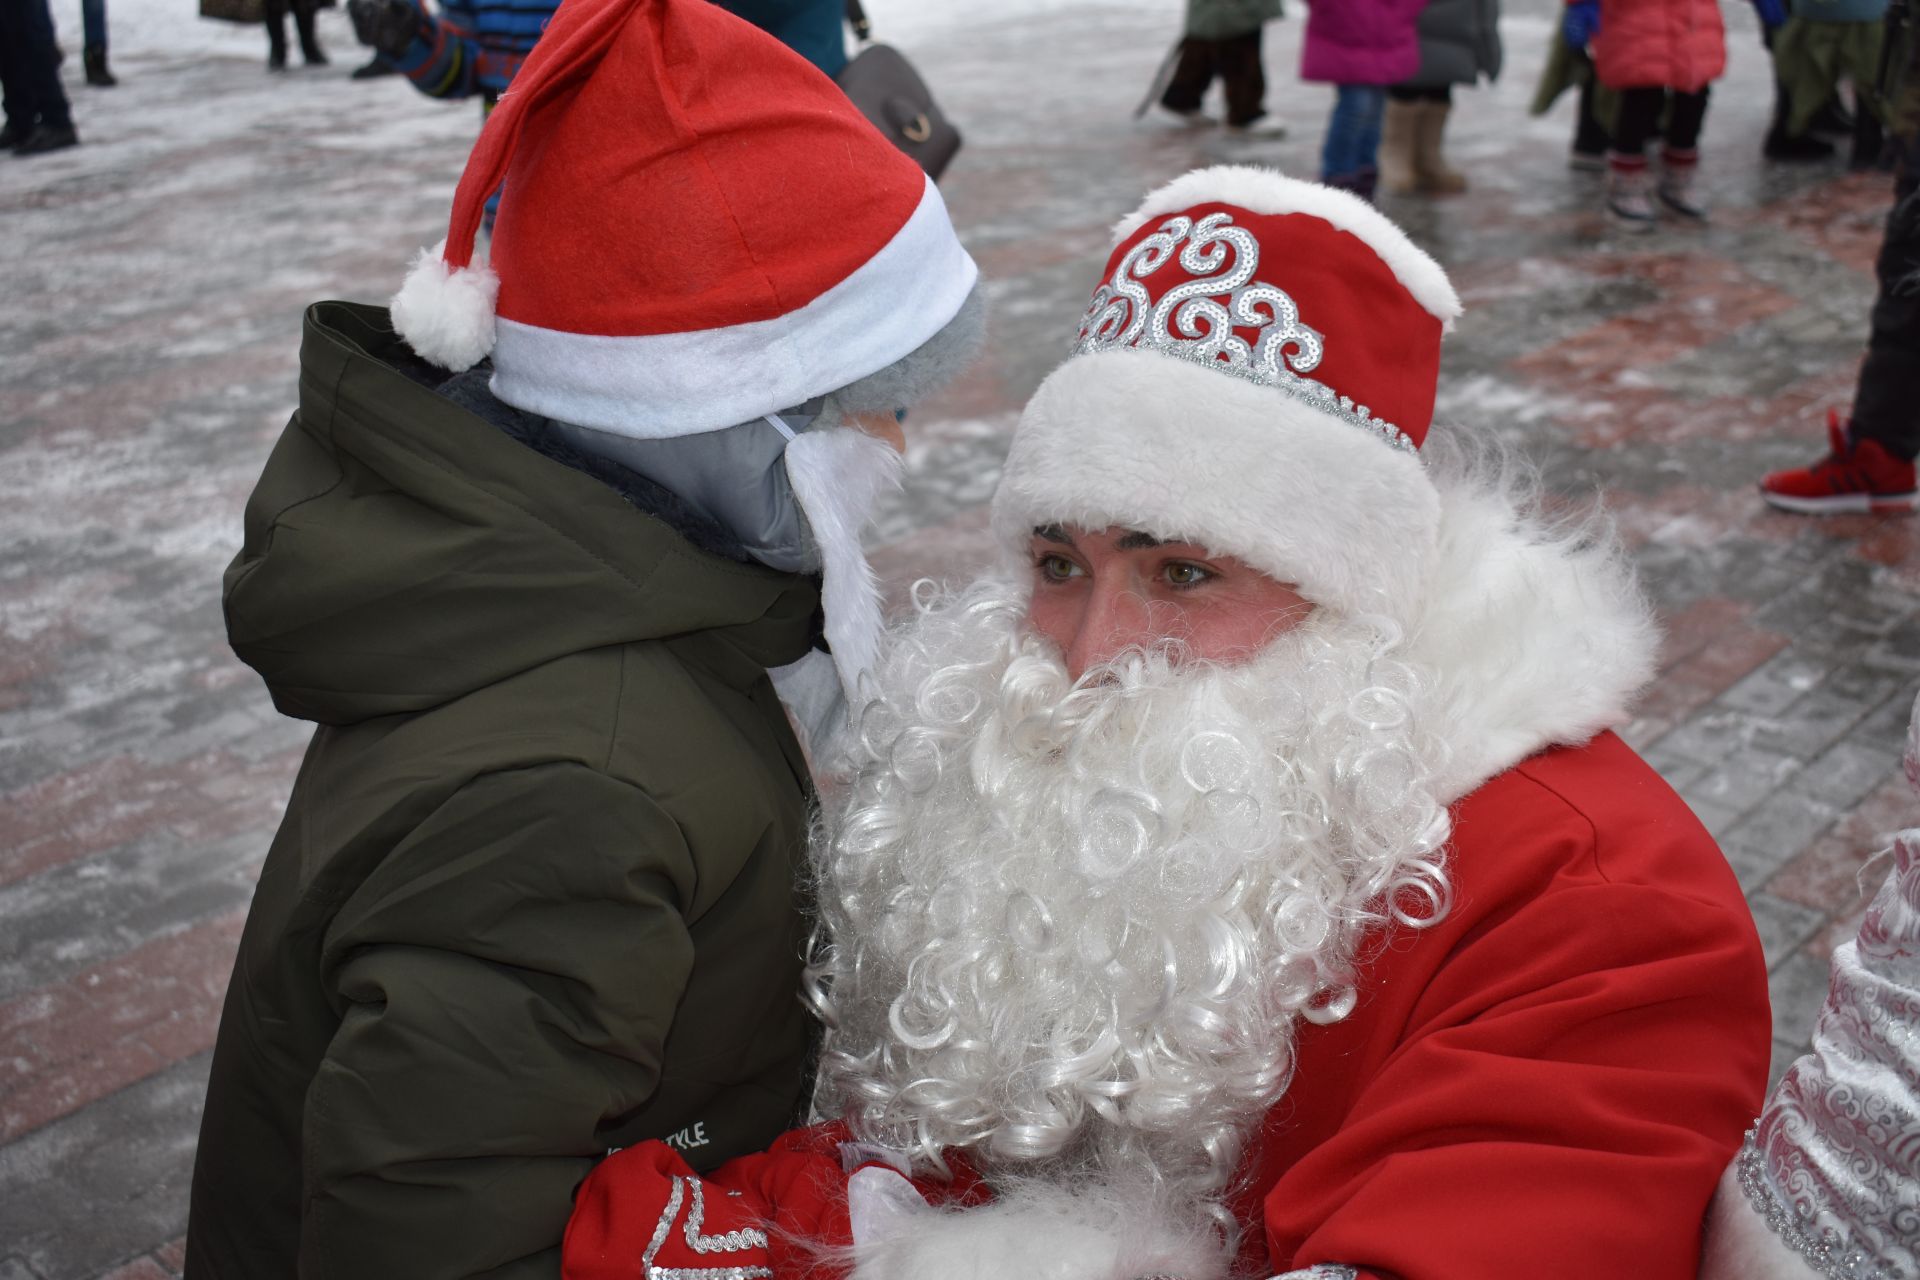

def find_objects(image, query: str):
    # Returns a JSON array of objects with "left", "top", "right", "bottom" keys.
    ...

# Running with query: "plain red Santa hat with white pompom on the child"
[{"left": 392, "top": 0, "right": 977, "bottom": 438}]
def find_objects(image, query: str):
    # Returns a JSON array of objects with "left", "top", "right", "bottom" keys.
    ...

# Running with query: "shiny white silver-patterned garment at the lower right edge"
[{"left": 1738, "top": 702, "right": 1920, "bottom": 1280}]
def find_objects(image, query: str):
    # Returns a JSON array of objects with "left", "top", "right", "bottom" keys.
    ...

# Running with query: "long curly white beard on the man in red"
[{"left": 806, "top": 581, "right": 1450, "bottom": 1201}]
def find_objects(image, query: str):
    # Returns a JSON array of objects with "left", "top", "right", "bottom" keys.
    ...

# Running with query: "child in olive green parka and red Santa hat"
[{"left": 186, "top": 0, "right": 979, "bottom": 1280}]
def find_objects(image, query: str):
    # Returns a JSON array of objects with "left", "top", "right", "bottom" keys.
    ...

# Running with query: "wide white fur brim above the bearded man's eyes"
[{"left": 993, "top": 349, "right": 1440, "bottom": 622}]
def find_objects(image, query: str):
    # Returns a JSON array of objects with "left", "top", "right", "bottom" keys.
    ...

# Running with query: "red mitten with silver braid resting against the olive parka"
[{"left": 561, "top": 1142, "right": 783, "bottom": 1280}]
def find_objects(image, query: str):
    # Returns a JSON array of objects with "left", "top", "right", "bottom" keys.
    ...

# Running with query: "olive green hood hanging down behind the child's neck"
[{"left": 225, "top": 303, "right": 818, "bottom": 725}]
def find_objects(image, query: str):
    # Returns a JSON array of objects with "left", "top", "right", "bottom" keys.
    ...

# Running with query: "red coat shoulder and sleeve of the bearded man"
[{"left": 1236, "top": 733, "right": 1770, "bottom": 1280}]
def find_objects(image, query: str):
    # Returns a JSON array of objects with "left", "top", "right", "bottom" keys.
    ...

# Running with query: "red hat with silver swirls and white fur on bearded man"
[{"left": 995, "top": 165, "right": 1459, "bottom": 620}]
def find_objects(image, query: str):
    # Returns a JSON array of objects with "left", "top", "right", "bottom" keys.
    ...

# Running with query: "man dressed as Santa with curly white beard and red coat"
[{"left": 566, "top": 167, "right": 1770, "bottom": 1280}]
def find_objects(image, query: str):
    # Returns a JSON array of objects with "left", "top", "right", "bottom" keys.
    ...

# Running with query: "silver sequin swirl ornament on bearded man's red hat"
[{"left": 1073, "top": 213, "right": 1417, "bottom": 453}]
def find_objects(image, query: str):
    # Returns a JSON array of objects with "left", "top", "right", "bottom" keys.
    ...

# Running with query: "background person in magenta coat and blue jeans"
[{"left": 1300, "top": 0, "right": 1427, "bottom": 200}]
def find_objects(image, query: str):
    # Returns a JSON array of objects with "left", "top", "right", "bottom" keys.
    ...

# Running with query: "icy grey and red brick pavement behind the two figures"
[{"left": 0, "top": 0, "right": 1920, "bottom": 1280}]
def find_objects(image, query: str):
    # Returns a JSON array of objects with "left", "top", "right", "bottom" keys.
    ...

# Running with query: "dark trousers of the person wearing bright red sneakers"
[{"left": 1853, "top": 148, "right": 1920, "bottom": 459}]
